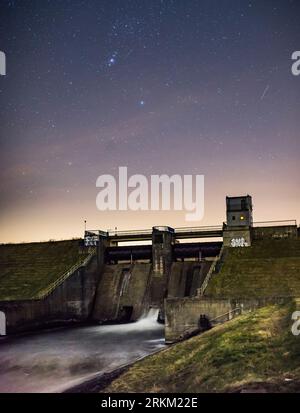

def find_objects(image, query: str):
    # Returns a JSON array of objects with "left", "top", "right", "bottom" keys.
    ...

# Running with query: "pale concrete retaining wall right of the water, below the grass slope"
[{"left": 165, "top": 297, "right": 288, "bottom": 343}]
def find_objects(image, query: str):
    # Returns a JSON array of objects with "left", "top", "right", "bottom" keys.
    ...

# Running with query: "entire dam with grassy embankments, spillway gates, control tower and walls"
[{"left": 0, "top": 195, "right": 300, "bottom": 342}]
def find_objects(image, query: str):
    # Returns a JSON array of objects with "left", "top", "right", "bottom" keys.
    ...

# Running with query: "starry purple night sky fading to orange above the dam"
[{"left": 0, "top": 0, "right": 300, "bottom": 242}]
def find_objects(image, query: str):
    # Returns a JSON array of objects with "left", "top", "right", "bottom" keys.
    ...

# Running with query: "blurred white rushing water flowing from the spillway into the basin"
[{"left": 0, "top": 309, "right": 164, "bottom": 392}]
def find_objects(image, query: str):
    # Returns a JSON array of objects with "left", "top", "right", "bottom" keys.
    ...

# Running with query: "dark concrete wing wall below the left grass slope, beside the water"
[{"left": 0, "top": 257, "right": 99, "bottom": 334}]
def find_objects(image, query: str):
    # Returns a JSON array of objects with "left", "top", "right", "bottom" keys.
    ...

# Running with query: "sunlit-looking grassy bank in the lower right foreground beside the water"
[{"left": 103, "top": 304, "right": 300, "bottom": 393}]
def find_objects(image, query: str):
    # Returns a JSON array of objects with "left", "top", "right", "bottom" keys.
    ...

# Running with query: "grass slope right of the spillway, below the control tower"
[{"left": 205, "top": 239, "right": 300, "bottom": 298}]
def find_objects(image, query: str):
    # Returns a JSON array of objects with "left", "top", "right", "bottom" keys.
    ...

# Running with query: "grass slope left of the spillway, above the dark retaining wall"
[{"left": 0, "top": 240, "right": 88, "bottom": 301}]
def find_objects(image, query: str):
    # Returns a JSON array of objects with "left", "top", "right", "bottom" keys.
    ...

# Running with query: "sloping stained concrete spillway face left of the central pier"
[{"left": 93, "top": 263, "right": 152, "bottom": 322}]
